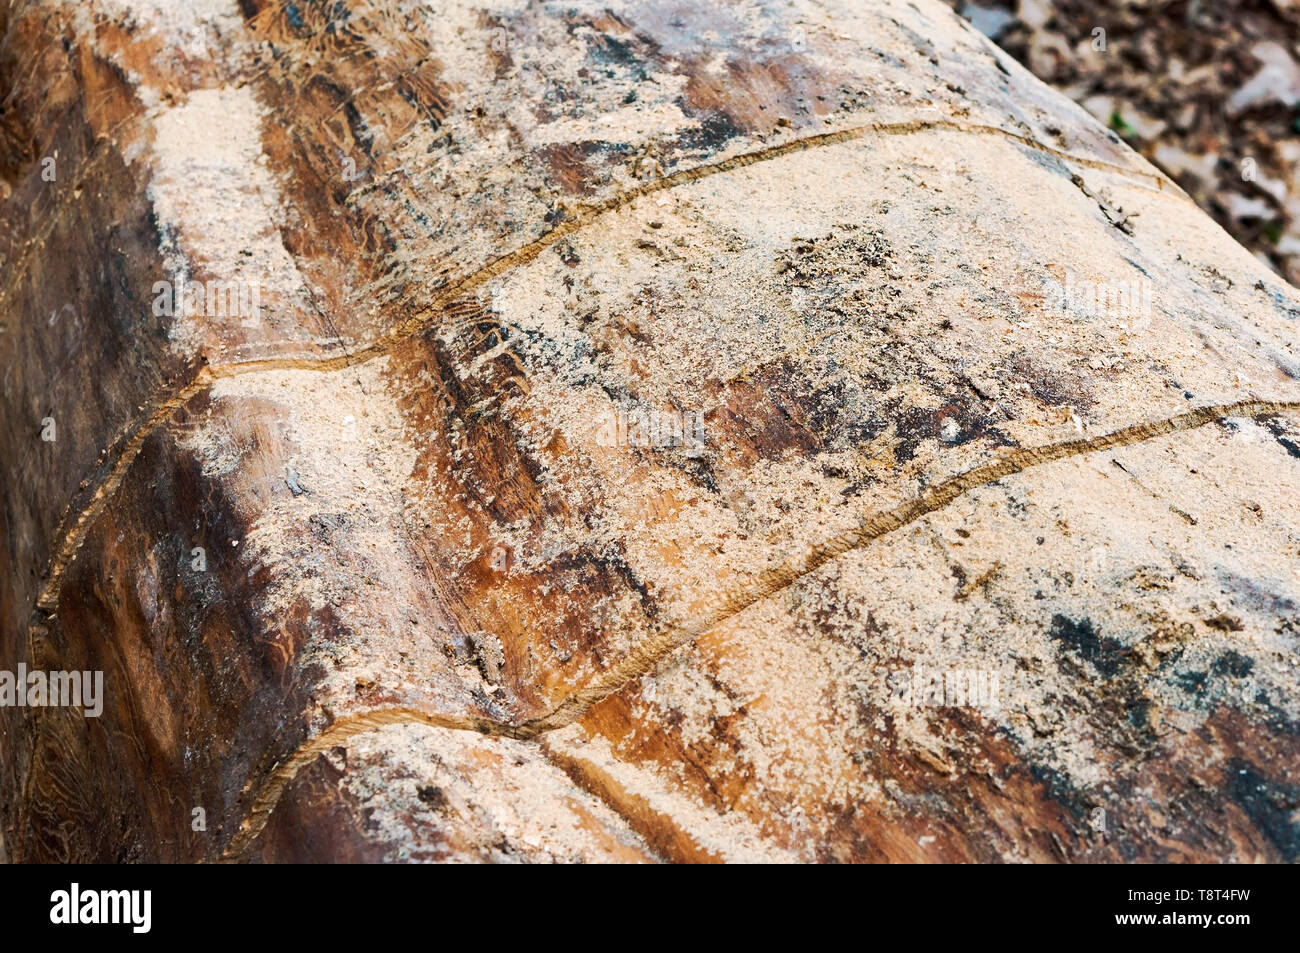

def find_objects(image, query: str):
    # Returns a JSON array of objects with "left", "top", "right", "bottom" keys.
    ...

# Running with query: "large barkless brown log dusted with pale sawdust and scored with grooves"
[{"left": 0, "top": 0, "right": 1300, "bottom": 861}]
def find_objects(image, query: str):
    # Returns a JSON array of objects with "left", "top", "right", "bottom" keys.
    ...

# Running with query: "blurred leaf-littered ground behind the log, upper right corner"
[{"left": 948, "top": 0, "right": 1300, "bottom": 285}]
